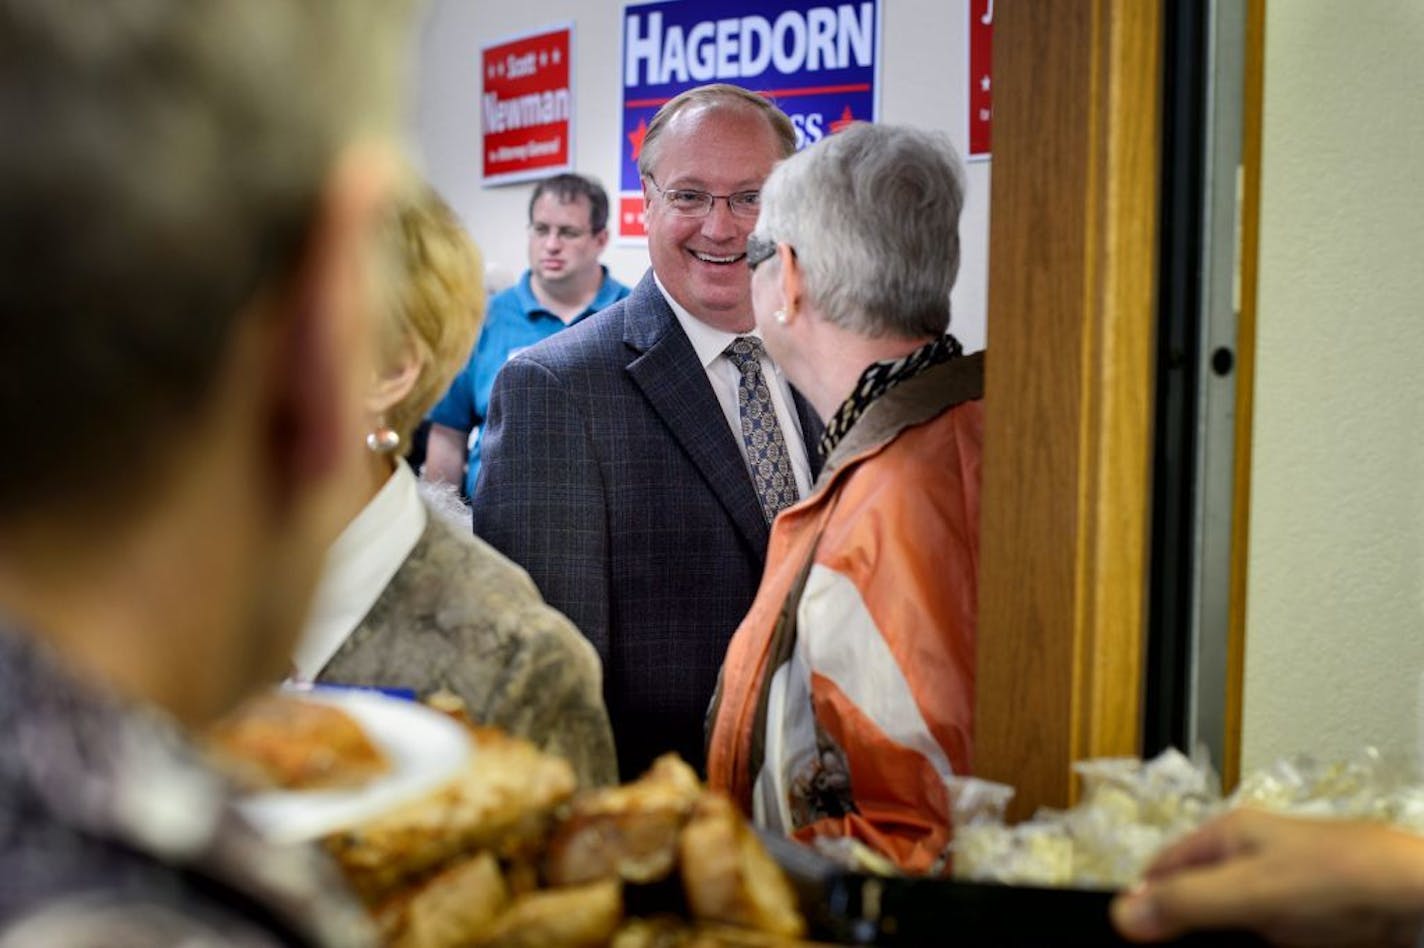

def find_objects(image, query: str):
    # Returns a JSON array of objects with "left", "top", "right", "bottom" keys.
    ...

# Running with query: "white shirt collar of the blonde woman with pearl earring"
[{"left": 292, "top": 458, "right": 426, "bottom": 682}]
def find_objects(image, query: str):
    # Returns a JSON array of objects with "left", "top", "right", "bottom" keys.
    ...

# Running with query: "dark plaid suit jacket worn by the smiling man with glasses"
[{"left": 473, "top": 272, "right": 822, "bottom": 779}]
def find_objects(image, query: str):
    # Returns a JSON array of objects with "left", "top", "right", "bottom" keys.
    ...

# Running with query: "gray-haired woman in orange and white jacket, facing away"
[{"left": 708, "top": 125, "right": 984, "bottom": 873}]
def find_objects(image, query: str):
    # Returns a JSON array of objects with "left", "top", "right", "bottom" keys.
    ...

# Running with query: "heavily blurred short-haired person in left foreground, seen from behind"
[{"left": 0, "top": 0, "right": 409, "bottom": 947}]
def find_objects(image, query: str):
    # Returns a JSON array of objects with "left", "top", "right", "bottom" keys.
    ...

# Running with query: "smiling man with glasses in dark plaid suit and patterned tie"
[{"left": 474, "top": 84, "right": 820, "bottom": 777}]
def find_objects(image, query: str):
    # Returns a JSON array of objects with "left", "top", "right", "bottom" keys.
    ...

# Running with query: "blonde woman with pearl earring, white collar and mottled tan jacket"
[{"left": 293, "top": 185, "right": 617, "bottom": 786}]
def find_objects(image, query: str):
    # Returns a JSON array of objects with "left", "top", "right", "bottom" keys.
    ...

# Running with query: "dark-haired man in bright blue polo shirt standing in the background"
[{"left": 424, "top": 174, "right": 628, "bottom": 497}]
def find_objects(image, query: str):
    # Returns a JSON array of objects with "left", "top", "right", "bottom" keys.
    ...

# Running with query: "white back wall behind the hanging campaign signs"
[{"left": 416, "top": 0, "right": 990, "bottom": 350}]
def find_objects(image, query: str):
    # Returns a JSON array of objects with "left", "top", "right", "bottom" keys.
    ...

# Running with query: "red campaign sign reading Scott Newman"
[{"left": 480, "top": 24, "right": 574, "bottom": 185}]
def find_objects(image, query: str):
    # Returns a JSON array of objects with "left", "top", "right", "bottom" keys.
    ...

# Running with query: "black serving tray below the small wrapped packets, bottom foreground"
[{"left": 763, "top": 837, "right": 1265, "bottom": 948}]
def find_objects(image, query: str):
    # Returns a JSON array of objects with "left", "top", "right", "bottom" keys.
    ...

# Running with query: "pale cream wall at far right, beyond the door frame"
[{"left": 1243, "top": 0, "right": 1424, "bottom": 769}]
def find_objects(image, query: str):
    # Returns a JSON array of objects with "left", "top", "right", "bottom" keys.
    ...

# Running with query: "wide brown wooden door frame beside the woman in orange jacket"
[{"left": 974, "top": 0, "right": 1162, "bottom": 816}]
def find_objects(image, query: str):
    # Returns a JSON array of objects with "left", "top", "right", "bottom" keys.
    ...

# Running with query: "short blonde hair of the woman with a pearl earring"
[{"left": 377, "top": 182, "right": 484, "bottom": 444}]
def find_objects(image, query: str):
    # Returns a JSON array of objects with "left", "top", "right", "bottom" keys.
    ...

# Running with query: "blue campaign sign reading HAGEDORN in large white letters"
[{"left": 617, "top": 0, "right": 880, "bottom": 242}]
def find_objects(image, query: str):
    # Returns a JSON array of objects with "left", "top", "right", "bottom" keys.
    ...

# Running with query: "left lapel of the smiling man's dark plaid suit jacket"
[{"left": 624, "top": 270, "right": 769, "bottom": 559}]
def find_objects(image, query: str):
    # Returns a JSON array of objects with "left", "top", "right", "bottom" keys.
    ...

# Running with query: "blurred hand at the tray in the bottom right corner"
[{"left": 1112, "top": 810, "right": 1424, "bottom": 948}]
